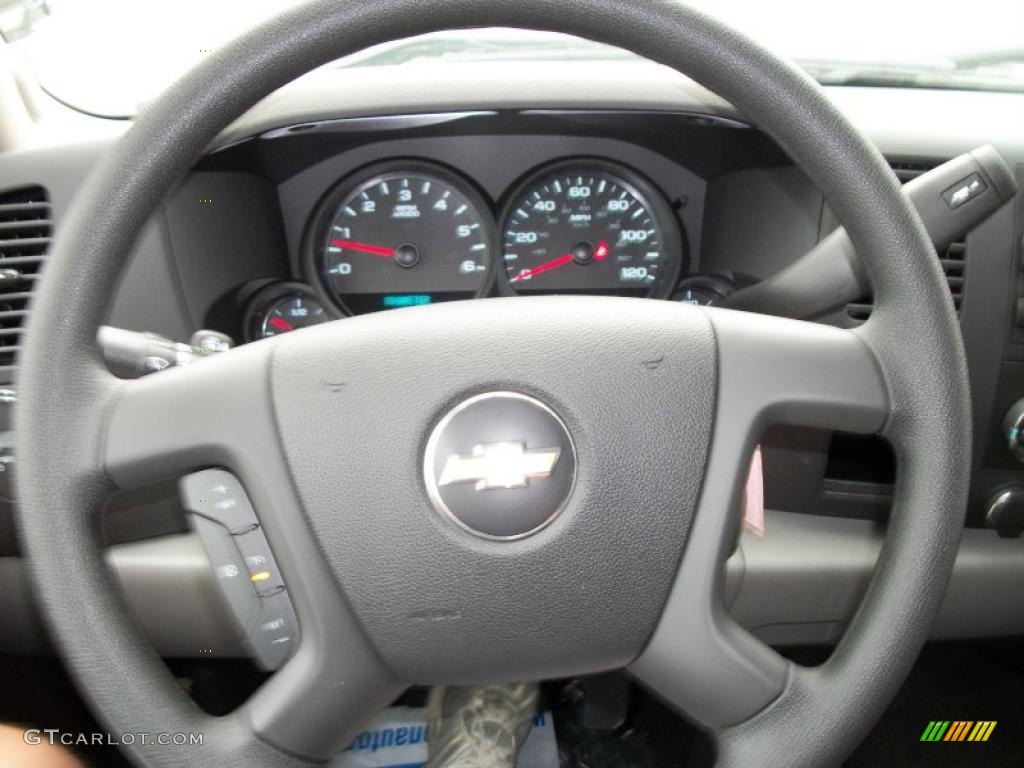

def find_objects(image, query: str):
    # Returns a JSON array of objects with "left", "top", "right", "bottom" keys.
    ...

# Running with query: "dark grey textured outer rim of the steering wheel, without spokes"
[{"left": 16, "top": 0, "right": 970, "bottom": 765}]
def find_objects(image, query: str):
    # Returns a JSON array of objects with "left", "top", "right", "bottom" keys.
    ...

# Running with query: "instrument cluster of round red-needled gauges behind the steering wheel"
[{"left": 246, "top": 158, "right": 729, "bottom": 340}]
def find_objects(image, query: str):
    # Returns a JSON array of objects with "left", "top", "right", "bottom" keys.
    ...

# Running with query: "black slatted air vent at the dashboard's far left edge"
[{"left": 0, "top": 186, "right": 53, "bottom": 384}]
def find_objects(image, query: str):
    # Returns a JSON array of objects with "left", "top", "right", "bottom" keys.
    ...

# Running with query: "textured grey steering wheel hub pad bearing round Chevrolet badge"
[{"left": 268, "top": 296, "right": 716, "bottom": 682}]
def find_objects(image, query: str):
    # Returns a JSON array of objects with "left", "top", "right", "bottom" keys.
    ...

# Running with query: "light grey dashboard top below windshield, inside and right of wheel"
[{"left": 207, "top": 61, "right": 1024, "bottom": 160}]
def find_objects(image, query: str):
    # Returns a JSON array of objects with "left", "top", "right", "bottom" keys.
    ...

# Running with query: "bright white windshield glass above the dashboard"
[{"left": 8, "top": 0, "right": 1024, "bottom": 117}]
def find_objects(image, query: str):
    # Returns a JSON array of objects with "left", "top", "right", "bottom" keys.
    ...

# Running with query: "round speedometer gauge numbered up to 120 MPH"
[{"left": 502, "top": 161, "right": 680, "bottom": 297}]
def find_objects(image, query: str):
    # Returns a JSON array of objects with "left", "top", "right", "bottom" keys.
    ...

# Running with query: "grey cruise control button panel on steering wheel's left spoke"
[{"left": 179, "top": 469, "right": 299, "bottom": 670}]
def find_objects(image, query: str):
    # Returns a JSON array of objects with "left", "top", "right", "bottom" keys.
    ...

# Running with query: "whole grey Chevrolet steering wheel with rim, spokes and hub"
[{"left": 16, "top": 0, "right": 971, "bottom": 768}]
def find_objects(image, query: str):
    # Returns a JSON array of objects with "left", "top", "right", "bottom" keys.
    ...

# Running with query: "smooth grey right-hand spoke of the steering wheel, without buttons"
[{"left": 632, "top": 309, "right": 889, "bottom": 730}]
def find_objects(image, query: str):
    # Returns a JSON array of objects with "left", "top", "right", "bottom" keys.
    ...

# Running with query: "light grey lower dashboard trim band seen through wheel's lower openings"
[{"left": 8, "top": 510, "right": 1024, "bottom": 658}]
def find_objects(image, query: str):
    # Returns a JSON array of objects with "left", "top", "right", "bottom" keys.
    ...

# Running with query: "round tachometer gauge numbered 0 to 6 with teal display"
[{"left": 316, "top": 164, "right": 494, "bottom": 314}]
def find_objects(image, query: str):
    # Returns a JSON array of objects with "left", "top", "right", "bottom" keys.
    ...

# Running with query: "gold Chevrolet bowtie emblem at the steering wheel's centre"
[{"left": 437, "top": 442, "right": 562, "bottom": 490}]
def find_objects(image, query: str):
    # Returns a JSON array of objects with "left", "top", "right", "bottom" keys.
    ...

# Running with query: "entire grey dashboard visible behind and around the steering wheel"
[{"left": 0, "top": 61, "right": 1024, "bottom": 655}]
